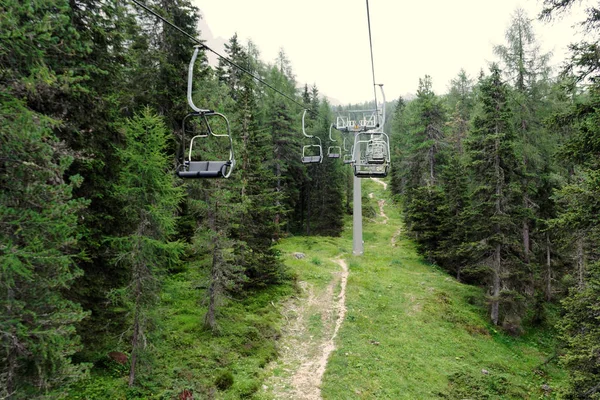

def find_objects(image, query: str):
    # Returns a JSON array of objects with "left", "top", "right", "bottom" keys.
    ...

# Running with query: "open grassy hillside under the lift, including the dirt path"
[{"left": 259, "top": 181, "right": 566, "bottom": 399}]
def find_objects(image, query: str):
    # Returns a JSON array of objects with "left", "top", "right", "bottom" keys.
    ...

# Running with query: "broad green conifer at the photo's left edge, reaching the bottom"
[{"left": 0, "top": 96, "right": 86, "bottom": 399}]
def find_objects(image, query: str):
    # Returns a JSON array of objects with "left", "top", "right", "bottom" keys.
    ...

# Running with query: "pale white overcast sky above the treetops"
[{"left": 192, "top": 0, "right": 577, "bottom": 104}]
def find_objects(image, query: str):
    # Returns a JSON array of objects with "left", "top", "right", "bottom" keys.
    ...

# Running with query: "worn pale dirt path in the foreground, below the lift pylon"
[{"left": 263, "top": 258, "right": 348, "bottom": 400}]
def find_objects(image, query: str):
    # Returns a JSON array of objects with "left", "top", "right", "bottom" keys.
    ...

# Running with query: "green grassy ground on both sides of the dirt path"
[{"left": 69, "top": 180, "right": 565, "bottom": 400}]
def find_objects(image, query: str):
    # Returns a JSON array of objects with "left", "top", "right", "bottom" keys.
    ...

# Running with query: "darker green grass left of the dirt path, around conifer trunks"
[{"left": 69, "top": 258, "right": 294, "bottom": 400}]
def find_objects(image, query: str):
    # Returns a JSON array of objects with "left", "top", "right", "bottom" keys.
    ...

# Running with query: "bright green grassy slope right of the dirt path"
[{"left": 280, "top": 181, "right": 566, "bottom": 400}]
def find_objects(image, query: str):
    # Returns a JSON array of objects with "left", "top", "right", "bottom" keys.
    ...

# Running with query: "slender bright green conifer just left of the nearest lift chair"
[{"left": 111, "top": 109, "right": 183, "bottom": 386}]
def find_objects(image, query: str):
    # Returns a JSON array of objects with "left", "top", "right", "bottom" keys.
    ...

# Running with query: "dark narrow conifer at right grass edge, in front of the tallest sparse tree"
[{"left": 465, "top": 65, "right": 522, "bottom": 330}]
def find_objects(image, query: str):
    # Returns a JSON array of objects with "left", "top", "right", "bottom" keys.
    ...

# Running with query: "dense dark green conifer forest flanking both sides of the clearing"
[{"left": 0, "top": 0, "right": 600, "bottom": 399}]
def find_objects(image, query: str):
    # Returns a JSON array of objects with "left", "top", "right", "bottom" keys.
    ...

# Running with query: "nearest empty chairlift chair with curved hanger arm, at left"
[{"left": 177, "top": 46, "right": 235, "bottom": 179}]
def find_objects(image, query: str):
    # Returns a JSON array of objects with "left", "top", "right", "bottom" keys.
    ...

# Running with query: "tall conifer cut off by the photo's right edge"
[{"left": 542, "top": 0, "right": 600, "bottom": 399}]
